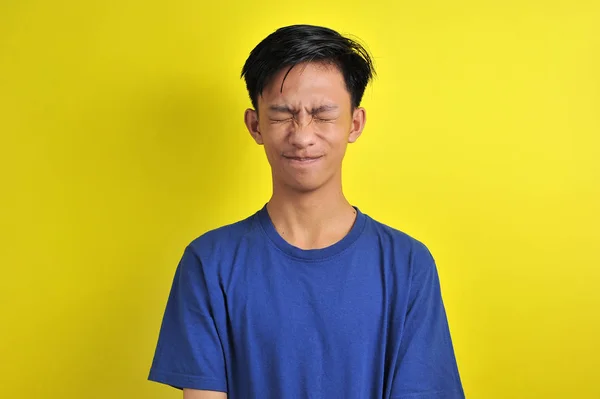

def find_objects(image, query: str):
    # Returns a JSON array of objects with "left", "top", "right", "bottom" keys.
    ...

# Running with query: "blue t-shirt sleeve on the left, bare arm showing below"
[{"left": 148, "top": 246, "right": 227, "bottom": 392}]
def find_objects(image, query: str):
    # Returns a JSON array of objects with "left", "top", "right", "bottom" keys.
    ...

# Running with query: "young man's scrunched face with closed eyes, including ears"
[{"left": 245, "top": 63, "right": 365, "bottom": 192}]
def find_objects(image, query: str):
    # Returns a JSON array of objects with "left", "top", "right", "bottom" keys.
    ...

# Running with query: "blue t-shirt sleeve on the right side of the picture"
[{"left": 391, "top": 242, "right": 465, "bottom": 399}]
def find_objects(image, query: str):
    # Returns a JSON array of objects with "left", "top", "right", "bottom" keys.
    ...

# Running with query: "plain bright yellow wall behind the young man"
[{"left": 0, "top": 0, "right": 600, "bottom": 399}]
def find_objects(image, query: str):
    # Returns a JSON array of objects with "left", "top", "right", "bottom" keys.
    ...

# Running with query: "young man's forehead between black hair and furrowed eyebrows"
[{"left": 259, "top": 63, "right": 350, "bottom": 107}]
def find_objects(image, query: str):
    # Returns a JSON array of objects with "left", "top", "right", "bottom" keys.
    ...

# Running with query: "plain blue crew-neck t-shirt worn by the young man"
[{"left": 149, "top": 206, "right": 464, "bottom": 399}]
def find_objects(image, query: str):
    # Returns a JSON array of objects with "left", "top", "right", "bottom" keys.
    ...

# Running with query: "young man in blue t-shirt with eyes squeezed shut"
[{"left": 149, "top": 25, "right": 464, "bottom": 399}]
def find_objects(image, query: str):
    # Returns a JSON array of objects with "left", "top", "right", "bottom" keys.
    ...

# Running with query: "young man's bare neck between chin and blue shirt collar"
[{"left": 267, "top": 180, "right": 356, "bottom": 249}]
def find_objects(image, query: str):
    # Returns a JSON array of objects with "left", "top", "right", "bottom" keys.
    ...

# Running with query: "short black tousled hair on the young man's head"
[{"left": 241, "top": 25, "right": 375, "bottom": 110}]
